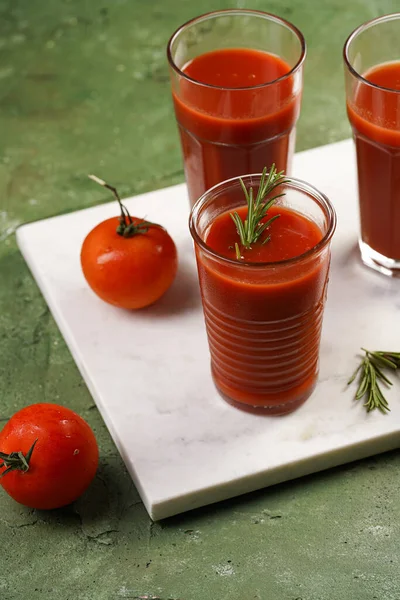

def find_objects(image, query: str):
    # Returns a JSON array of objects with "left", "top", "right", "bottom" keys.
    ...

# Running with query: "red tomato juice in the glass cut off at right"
[{"left": 347, "top": 62, "right": 400, "bottom": 260}]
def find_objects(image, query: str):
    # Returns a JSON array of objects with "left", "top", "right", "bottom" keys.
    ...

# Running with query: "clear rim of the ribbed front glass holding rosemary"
[{"left": 189, "top": 173, "right": 337, "bottom": 269}]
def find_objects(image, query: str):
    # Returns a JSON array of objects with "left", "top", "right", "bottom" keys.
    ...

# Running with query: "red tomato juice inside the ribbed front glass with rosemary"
[{"left": 196, "top": 206, "right": 329, "bottom": 414}]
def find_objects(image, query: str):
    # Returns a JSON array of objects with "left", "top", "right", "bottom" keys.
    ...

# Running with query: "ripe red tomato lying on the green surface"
[{"left": 0, "top": 403, "right": 99, "bottom": 509}]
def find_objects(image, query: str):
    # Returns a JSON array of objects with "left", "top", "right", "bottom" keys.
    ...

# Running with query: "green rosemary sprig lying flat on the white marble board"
[{"left": 347, "top": 348, "right": 400, "bottom": 413}]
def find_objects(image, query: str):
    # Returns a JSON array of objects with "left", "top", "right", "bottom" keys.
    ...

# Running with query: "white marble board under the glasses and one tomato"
[{"left": 17, "top": 140, "right": 400, "bottom": 520}]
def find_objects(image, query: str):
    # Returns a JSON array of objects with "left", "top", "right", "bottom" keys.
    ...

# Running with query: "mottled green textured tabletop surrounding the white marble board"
[{"left": 0, "top": 0, "right": 400, "bottom": 600}]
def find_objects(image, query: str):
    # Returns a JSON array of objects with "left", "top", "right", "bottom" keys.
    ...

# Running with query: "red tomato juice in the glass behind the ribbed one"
[{"left": 173, "top": 48, "right": 300, "bottom": 204}]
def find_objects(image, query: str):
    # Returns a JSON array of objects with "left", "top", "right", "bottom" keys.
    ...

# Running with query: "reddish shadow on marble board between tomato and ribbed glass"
[{"left": 138, "top": 262, "right": 201, "bottom": 318}]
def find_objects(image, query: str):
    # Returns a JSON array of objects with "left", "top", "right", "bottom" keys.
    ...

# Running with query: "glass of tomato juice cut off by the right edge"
[{"left": 344, "top": 13, "right": 400, "bottom": 276}]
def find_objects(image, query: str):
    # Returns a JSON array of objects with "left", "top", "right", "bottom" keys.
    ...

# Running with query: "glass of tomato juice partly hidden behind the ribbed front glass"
[{"left": 167, "top": 10, "right": 306, "bottom": 205}]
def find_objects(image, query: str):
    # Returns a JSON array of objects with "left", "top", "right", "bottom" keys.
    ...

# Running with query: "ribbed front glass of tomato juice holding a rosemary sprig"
[{"left": 189, "top": 175, "right": 336, "bottom": 414}]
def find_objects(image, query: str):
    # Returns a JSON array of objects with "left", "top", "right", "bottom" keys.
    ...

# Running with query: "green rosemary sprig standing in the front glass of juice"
[{"left": 231, "top": 164, "right": 286, "bottom": 260}]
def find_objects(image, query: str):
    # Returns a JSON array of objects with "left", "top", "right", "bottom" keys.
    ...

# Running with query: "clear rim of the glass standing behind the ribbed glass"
[{"left": 167, "top": 8, "right": 307, "bottom": 91}]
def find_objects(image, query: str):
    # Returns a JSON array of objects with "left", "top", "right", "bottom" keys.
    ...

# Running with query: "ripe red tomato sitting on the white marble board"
[{"left": 81, "top": 217, "right": 178, "bottom": 309}]
